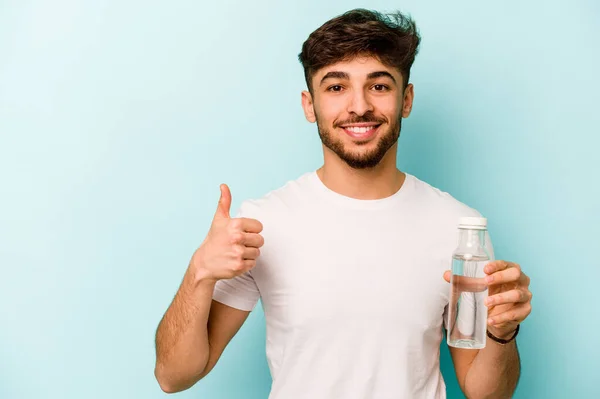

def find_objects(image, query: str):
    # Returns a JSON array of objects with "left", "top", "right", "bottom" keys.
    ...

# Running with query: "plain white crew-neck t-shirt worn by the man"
[{"left": 214, "top": 172, "right": 491, "bottom": 399}]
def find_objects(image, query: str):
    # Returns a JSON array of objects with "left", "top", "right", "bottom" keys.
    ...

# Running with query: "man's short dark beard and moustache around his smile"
[{"left": 315, "top": 113, "right": 402, "bottom": 169}]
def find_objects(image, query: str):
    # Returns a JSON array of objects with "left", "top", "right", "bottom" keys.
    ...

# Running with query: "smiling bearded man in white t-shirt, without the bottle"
[{"left": 155, "top": 10, "right": 531, "bottom": 399}]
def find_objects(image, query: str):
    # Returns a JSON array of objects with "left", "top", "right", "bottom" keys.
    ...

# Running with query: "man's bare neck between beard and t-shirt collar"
[{"left": 317, "top": 143, "right": 406, "bottom": 200}]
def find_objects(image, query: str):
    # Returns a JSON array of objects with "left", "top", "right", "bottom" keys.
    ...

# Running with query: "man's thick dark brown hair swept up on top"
[{"left": 298, "top": 8, "right": 421, "bottom": 91}]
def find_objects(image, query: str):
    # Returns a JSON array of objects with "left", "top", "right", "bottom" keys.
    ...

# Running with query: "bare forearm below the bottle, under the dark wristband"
[{"left": 450, "top": 338, "right": 521, "bottom": 399}]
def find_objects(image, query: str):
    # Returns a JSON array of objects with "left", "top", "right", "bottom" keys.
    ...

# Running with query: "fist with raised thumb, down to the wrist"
[{"left": 190, "top": 184, "right": 264, "bottom": 281}]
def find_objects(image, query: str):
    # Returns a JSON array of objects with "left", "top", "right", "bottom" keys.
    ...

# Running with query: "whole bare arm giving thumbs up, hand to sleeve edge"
[{"left": 154, "top": 185, "right": 264, "bottom": 393}]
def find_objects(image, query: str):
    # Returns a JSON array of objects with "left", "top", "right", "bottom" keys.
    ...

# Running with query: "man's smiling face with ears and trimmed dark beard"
[{"left": 302, "top": 57, "right": 413, "bottom": 169}]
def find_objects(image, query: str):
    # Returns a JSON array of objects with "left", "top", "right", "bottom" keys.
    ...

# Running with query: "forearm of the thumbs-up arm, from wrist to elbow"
[{"left": 155, "top": 271, "right": 215, "bottom": 392}]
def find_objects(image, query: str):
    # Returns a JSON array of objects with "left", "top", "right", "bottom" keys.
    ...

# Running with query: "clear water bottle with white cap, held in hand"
[{"left": 446, "top": 217, "right": 492, "bottom": 349}]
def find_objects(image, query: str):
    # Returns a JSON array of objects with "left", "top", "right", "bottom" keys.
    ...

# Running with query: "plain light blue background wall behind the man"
[{"left": 0, "top": 0, "right": 600, "bottom": 399}]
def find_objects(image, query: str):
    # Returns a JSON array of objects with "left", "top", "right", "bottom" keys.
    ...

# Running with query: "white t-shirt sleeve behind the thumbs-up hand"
[{"left": 213, "top": 203, "right": 260, "bottom": 312}]
